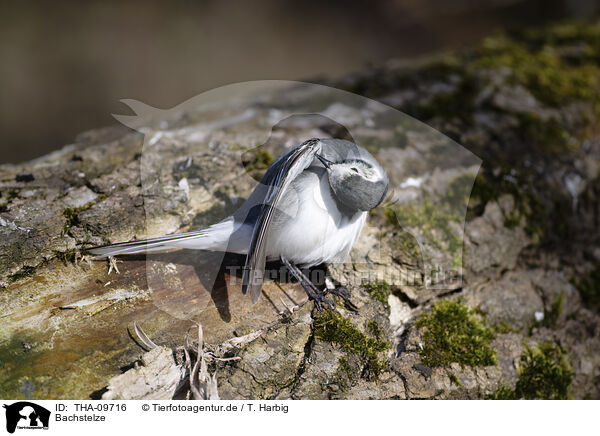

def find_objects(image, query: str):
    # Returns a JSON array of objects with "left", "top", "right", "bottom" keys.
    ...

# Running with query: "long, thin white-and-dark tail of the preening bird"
[{"left": 85, "top": 218, "right": 234, "bottom": 257}]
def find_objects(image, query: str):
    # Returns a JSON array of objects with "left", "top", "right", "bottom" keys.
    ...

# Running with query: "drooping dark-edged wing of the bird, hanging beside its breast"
[{"left": 242, "top": 139, "right": 321, "bottom": 303}]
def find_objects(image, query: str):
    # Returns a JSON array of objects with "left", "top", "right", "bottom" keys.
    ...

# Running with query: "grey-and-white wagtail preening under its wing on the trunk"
[{"left": 86, "top": 138, "right": 389, "bottom": 309}]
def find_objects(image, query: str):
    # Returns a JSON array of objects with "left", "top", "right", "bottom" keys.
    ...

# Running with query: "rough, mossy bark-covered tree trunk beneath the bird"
[{"left": 0, "top": 25, "right": 600, "bottom": 399}]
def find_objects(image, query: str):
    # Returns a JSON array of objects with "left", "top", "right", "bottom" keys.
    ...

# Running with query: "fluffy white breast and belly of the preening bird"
[{"left": 267, "top": 167, "right": 367, "bottom": 266}]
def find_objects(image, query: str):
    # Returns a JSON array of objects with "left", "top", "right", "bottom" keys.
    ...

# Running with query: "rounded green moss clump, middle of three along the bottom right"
[{"left": 415, "top": 299, "right": 496, "bottom": 367}]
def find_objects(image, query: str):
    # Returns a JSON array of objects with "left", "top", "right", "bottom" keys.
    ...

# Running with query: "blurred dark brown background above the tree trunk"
[{"left": 0, "top": 0, "right": 600, "bottom": 163}]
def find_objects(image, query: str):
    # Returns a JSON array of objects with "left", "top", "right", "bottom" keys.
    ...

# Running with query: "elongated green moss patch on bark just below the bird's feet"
[{"left": 314, "top": 311, "right": 390, "bottom": 379}]
